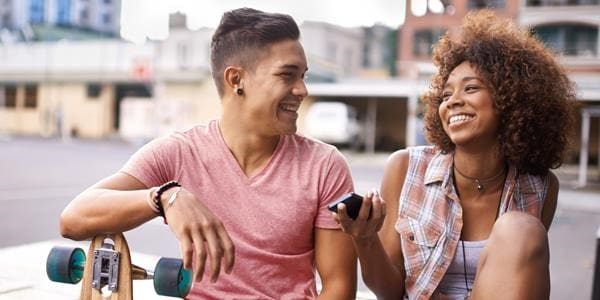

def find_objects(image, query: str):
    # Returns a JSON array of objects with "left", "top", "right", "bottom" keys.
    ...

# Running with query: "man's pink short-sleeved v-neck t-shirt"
[{"left": 122, "top": 121, "right": 353, "bottom": 299}]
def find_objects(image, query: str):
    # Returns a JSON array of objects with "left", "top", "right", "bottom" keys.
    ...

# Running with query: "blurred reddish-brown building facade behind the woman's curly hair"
[{"left": 396, "top": 0, "right": 600, "bottom": 161}]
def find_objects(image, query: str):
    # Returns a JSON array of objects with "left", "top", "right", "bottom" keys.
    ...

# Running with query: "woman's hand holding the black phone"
[{"left": 333, "top": 189, "right": 385, "bottom": 241}]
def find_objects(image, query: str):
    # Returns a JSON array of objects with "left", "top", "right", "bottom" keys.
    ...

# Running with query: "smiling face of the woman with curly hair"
[{"left": 438, "top": 62, "right": 500, "bottom": 147}]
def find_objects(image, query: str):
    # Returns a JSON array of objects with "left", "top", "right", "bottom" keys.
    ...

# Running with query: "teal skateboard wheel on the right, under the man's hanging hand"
[{"left": 154, "top": 257, "right": 192, "bottom": 298}]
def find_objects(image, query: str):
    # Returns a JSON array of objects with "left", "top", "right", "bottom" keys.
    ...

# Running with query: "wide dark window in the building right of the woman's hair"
[{"left": 534, "top": 24, "right": 598, "bottom": 56}]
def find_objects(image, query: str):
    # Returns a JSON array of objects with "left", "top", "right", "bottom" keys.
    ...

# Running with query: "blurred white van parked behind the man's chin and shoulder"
[{"left": 306, "top": 102, "right": 361, "bottom": 146}]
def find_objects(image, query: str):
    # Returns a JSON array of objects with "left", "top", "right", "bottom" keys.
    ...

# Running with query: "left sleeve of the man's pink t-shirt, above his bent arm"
[{"left": 121, "top": 135, "right": 180, "bottom": 187}]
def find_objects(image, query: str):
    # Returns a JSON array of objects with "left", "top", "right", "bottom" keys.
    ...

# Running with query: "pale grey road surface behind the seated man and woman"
[{"left": 0, "top": 138, "right": 600, "bottom": 299}]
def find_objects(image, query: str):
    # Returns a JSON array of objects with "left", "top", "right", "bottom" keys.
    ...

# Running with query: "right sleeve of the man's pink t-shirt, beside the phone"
[{"left": 315, "top": 150, "right": 354, "bottom": 229}]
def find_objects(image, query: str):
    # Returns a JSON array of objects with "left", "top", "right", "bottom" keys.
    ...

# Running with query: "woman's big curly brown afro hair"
[{"left": 423, "top": 10, "right": 577, "bottom": 175}]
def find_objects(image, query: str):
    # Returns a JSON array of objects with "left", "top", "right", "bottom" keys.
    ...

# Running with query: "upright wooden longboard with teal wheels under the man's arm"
[{"left": 46, "top": 233, "right": 192, "bottom": 300}]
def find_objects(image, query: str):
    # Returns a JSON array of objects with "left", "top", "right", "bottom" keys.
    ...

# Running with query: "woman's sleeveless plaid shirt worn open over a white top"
[{"left": 395, "top": 146, "right": 547, "bottom": 299}]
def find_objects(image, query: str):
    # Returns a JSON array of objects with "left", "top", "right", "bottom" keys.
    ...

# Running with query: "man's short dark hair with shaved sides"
[{"left": 210, "top": 8, "right": 300, "bottom": 96}]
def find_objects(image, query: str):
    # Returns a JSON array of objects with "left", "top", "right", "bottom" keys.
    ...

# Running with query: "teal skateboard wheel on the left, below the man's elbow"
[{"left": 46, "top": 247, "right": 85, "bottom": 284}]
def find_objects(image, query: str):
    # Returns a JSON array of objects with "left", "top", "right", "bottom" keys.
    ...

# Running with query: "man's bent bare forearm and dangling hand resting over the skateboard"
[{"left": 60, "top": 172, "right": 235, "bottom": 281}]
